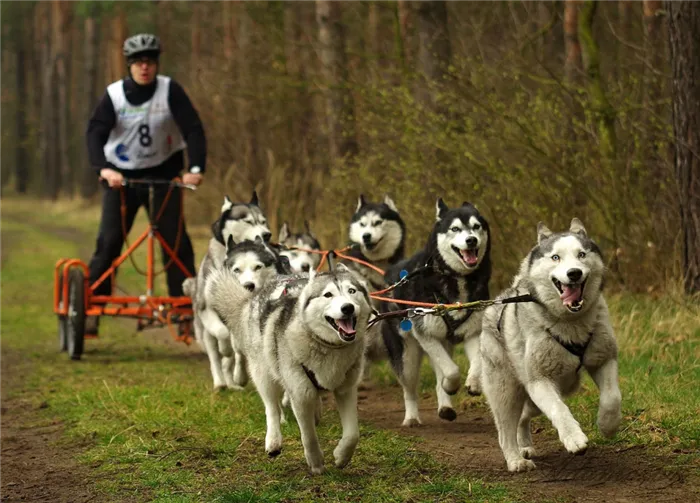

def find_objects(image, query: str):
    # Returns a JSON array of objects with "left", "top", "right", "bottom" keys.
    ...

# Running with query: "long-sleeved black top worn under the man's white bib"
[{"left": 87, "top": 77, "right": 207, "bottom": 179}]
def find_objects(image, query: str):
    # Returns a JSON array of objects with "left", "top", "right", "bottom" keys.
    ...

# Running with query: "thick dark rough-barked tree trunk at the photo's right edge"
[{"left": 664, "top": 0, "right": 700, "bottom": 294}]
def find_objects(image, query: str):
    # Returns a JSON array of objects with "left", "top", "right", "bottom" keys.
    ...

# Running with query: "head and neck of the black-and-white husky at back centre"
[{"left": 343, "top": 194, "right": 406, "bottom": 290}]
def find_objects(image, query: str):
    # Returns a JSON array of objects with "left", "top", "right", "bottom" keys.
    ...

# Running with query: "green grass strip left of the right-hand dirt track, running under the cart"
[{"left": 0, "top": 199, "right": 517, "bottom": 502}]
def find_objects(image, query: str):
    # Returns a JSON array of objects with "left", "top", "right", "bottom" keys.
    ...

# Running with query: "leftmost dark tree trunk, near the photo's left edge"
[{"left": 15, "top": 15, "right": 30, "bottom": 194}]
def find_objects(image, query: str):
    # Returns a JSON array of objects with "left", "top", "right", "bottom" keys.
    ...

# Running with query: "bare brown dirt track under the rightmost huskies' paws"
[{"left": 359, "top": 385, "right": 700, "bottom": 503}]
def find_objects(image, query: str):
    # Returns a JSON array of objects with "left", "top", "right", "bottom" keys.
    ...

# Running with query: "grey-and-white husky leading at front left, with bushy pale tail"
[{"left": 208, "top": 264, "right": 370, "bottom": 474}]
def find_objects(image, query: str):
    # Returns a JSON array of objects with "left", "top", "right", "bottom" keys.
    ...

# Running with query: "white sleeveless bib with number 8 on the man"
[{"left": 104, "top": 75, "right": 186, "bottom": 169}]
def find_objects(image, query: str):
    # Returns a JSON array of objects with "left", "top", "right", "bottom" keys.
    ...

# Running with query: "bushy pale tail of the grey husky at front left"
[{"left": 205, "top": 267, "right": 250, "bottom": 331}]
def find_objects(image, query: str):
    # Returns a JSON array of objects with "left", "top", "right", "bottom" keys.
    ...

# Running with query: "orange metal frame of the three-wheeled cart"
[{"left": 53, "top": 207, "right": 193, "bottom": 345}]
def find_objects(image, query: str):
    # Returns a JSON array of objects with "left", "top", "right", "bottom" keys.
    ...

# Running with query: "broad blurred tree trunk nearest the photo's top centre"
[{"left": 316, "top": 0, "right": 358, "bottom": 159}]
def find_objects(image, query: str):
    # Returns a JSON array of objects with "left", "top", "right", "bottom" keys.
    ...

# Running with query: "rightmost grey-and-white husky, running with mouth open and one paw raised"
[{"left": 481, "top": 218, "right": 621, "bottom": 472}]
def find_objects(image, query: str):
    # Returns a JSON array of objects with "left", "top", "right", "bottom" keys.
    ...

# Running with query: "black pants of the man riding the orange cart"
[{"left": 89, "top": 185, "right": 195, "bottom": 297}]
